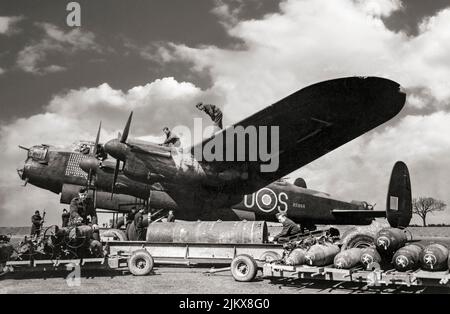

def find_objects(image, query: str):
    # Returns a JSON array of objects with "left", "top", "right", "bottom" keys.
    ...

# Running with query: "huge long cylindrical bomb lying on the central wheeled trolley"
[{"left": 147, "top": 221, "right": 268, "bottom": 244}]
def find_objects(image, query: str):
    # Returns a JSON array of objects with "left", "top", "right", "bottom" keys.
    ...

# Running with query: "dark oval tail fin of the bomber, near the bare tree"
[{"left": 386, "top": 161, "right": 412, "bottom": 228}]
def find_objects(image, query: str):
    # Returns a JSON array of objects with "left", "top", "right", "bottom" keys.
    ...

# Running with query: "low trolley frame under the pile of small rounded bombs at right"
[{"left": 263, "top": 263, "right": 450, "bottom": 288}]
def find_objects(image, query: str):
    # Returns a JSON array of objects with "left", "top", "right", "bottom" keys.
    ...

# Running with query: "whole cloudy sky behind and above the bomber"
[{"left": 0, "top": 0, "right": 450, "bottom": 226}]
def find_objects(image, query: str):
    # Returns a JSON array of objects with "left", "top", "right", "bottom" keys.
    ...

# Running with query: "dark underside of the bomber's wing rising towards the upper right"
[{"left": 191, "top": 77, "right": 406, "bottom": 192}]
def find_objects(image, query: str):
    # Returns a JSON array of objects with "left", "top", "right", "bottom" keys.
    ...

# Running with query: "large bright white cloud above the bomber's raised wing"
[{"left": 162, "top": 0, "right": 450, "bottom": 121}]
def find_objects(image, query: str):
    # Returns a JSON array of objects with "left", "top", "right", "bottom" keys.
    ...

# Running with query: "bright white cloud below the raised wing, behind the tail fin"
[{"left": 291, "top": 111, "right": 450, "bottom": 223}]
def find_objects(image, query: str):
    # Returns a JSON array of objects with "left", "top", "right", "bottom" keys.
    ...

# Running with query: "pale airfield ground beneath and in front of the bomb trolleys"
[{"left": 0, "top": 227, "right": 450, "bottom": 294}]
